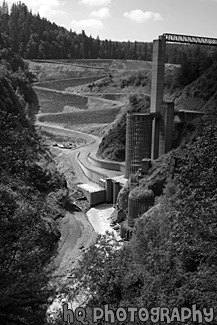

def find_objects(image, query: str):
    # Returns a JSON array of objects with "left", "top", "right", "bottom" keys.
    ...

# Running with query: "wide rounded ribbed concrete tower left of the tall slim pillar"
[{"left": 125, "top": 113, "right": 154, "bottom": 178}]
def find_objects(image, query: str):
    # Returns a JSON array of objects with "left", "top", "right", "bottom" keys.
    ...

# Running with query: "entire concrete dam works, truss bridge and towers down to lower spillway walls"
[{"left": 78, "top": 34, "right": 214, "bottom": 240}]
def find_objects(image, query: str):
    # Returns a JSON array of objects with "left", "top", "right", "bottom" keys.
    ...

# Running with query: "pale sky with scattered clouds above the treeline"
[{"left": 3, "top": 0, "right": 217, "bottom": 42}]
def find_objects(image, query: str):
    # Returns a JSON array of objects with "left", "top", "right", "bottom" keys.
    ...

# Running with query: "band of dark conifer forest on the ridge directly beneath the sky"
[{"left": 0, "top": 0, "right": 215, "bottom": 63}]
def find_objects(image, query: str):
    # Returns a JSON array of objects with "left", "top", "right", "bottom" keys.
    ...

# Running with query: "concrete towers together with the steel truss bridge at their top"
[{"left": 125, "top": 33, "right": 217, "bottom": 178}]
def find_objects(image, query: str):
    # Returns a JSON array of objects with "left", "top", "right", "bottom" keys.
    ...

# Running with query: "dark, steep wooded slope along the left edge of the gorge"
[{"left": 0, "top": 34, "right": 67, "bottom": 325}]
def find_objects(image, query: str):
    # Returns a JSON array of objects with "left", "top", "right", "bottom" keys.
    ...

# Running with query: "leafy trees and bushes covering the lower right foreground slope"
[{"left": 64, "top": 117, "right": 217, "bottom": 325}]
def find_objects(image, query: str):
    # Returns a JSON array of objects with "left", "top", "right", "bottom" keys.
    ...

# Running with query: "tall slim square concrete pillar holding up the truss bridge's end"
[{"left": 151, "top": 36, "right": 166, "bottom": 159}]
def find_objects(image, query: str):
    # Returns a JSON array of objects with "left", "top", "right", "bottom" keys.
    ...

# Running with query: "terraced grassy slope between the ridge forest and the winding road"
[{"left": 30, "top": 60, "right": 154, "bottom": 135}]
